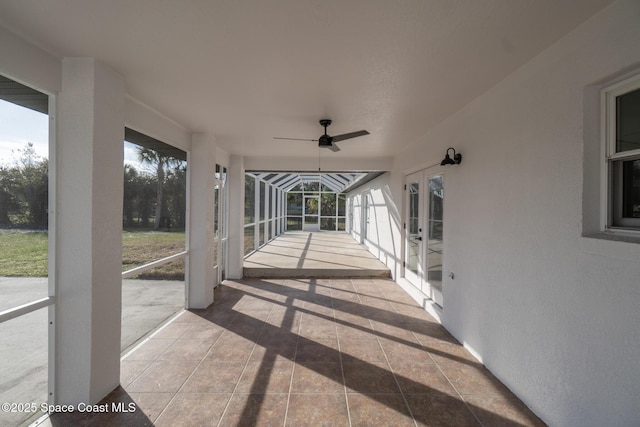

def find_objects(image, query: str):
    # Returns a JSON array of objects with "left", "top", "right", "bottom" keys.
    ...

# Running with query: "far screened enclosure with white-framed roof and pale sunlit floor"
[{"left": 243, "top": 172, "right": 390, "bottom": 277}]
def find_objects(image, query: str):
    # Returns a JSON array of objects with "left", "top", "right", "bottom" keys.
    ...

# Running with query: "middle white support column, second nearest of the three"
[{"left": 187, "top": 134, "right": 217, "bottom": 308}]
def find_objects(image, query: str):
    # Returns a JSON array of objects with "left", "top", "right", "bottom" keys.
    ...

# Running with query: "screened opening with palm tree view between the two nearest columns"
[{"left": 120, "top": 134, "right": 185, "bottom": 352}]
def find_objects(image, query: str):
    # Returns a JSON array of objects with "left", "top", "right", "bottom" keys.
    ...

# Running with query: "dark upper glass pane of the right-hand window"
[{"left": 616, "top": 89, "right": 640, "bottom": 153}]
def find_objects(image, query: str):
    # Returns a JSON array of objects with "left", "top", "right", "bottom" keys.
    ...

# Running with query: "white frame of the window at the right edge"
[{"left": 600, "top": 74, "right": 640, "bottom": 235}]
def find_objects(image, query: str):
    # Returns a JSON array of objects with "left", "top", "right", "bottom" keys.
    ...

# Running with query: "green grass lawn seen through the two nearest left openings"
[{"left": 0, "top": 229, "right": 185, "bottom": 280}]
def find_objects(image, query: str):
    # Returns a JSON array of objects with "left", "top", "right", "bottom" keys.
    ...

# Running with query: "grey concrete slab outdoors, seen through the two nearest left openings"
[{"left": 0, "top": 277, "right": 185, "bottom": 426}]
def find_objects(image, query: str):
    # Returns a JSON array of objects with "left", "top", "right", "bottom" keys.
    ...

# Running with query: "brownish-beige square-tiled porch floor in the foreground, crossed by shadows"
[{"left": 51, "top": 278, "right": 543, "bottom": 427}]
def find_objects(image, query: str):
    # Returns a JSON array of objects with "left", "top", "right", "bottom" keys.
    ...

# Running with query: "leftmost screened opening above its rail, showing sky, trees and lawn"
[{"left": 0, "top": 95, "right": 49, "bottom": 304}]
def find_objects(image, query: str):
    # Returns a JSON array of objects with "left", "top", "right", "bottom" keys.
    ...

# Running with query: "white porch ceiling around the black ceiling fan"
[{"left": 0, "top": 0, "right": 611, "bottom": 158}]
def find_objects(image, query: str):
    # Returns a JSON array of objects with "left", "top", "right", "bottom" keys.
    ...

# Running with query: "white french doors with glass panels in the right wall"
[{"left": 404, "top": 171, "right": 444, "bottom": 307}]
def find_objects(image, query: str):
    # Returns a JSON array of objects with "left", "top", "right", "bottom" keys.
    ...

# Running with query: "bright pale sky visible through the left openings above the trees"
[{"left": 0, "top": 99, "right": 146, "bottom": 172}]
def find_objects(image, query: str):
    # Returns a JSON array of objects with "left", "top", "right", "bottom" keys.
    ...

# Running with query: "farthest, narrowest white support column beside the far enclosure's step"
[{"left": 228, "top": 155, "right": 244, "bottom": 279}]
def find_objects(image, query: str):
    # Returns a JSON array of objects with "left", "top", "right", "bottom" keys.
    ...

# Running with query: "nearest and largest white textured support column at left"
[{"left": 54, "top": 58, "right": 124, "bottom": 405}]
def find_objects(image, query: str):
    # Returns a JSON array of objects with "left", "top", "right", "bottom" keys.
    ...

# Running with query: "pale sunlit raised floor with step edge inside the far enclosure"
[{"left": 244, "top": 231, "right": 390, "bottom": 278}]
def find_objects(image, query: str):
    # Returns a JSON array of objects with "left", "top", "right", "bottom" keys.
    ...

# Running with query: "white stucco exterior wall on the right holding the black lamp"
[{"left": 350, "top": 0, "right": 640, "bottom": 426}]
